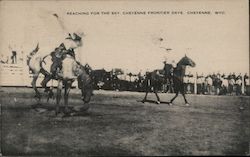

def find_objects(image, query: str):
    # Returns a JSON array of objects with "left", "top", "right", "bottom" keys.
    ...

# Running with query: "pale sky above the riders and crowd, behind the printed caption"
[{"left": 0, "top": 0, "right": 249, "bottom": 74}]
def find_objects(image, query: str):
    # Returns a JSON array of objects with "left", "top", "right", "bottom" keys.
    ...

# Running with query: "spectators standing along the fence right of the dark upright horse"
[{"left": 184, "top": 73, "right": 249, "bottom": 95}]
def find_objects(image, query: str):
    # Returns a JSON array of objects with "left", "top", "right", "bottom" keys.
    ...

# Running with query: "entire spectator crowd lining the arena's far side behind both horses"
[{"left": 0, "top": 51, "right": 250, "bottom": 95}]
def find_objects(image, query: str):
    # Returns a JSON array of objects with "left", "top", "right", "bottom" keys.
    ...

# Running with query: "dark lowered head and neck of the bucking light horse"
[{"left": 77, "top": 65, "right": 93, "bottom": 103}]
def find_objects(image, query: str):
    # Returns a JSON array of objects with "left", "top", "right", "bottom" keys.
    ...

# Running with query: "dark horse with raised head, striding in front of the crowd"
[{"left": 142, "top": 55, "right": 195, "bottom": 105}]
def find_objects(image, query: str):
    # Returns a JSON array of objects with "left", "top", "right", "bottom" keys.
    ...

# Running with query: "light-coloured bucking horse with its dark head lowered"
[{"left": 28, "top": 46, "right": 93, "bottom": 114}]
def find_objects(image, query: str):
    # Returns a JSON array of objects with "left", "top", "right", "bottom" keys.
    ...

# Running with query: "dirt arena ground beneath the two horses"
[{"left": 0, "top": 87, "right": 250, "bottom": 156}]
